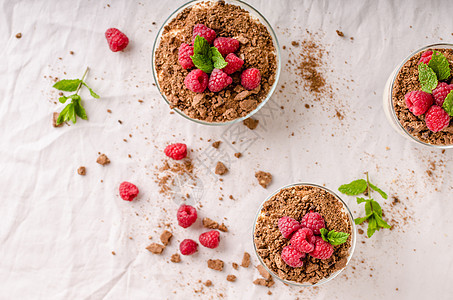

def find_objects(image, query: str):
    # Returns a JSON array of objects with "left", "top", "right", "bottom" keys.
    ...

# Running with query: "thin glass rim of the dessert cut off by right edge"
[{"left": 388, "top": 43, "right": 453, "bottom": 149}]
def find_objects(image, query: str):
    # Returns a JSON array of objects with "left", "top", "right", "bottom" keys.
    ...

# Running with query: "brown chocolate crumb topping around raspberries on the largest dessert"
[{"left": 155, "top": 1, "right": 277, "bottom": 122}]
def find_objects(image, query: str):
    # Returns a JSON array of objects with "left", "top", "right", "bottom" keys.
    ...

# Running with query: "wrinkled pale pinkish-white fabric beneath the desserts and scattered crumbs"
[{"left": 0, "top": 0, "right": 453, "bottom": 299}]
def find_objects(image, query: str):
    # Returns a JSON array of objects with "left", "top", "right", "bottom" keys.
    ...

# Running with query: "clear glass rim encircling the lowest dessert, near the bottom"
[{"left": 252, "top": 183, "right": 357, "bottom": 287}]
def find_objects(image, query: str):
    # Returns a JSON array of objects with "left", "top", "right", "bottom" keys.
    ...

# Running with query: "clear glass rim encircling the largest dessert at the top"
[{"left": 151, "top": 0, "right": 281, "bottom": 126}]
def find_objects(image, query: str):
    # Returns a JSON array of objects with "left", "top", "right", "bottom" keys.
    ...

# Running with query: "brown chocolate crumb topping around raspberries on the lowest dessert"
[{"left": 254, "top": 186, "right": 352, "bottom": 284}]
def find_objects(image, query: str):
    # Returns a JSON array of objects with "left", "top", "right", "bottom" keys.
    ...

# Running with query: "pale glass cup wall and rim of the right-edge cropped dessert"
[{"left": 382, "top": 44, "right": 453, "bottom": 149}]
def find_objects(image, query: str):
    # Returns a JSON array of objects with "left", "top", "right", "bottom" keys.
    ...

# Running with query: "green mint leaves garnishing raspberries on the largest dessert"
[{"left": 190, "top": 35, "right": 228, "bottom": 73}]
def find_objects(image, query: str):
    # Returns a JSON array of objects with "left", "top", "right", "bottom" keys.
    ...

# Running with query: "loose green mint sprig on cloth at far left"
[{"left": 53, "top": 68, "right": 99, "bottom": 125}]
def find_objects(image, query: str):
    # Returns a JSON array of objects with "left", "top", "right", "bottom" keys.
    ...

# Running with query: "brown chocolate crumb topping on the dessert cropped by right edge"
[{"left": 392, "top": 49, "right": 453, "bottom": 145}]
